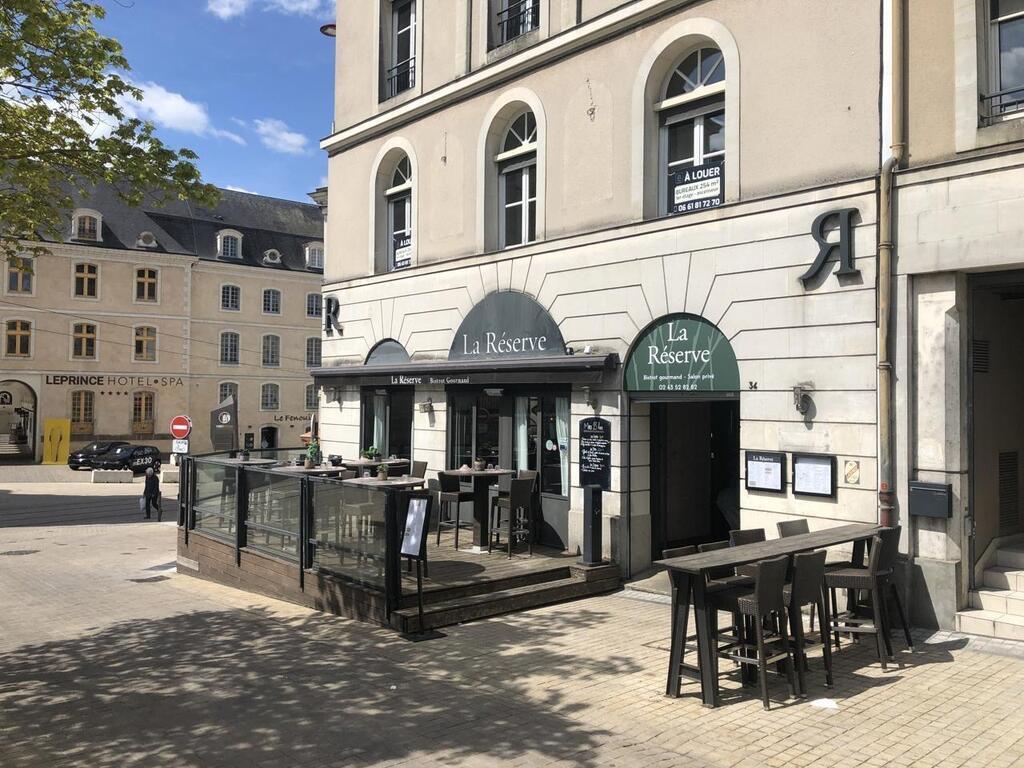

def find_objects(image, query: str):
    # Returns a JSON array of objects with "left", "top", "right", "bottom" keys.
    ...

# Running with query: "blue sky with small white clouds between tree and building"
[{"left": 98, "top": 0, "right": 335, "bottom": 203}]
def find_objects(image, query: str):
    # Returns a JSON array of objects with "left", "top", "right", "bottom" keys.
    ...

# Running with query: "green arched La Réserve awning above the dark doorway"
[{"left": 624, "top": 313, "right": 739, "bottom": 392}]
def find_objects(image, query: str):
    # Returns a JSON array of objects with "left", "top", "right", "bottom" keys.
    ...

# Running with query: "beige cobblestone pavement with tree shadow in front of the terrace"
[{"left": 0, "top": 485, "right": 1024, "bottom": 768}]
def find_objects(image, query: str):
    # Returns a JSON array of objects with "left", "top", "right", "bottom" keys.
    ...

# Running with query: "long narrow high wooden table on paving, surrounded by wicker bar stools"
[{"left": 656, "top": 523, "right": 882, "bottom": 707}]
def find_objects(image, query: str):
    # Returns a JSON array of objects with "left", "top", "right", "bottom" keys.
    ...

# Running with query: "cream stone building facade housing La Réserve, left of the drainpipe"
[{"left": 314, "top": 0, "right": 883, "bottom": 577}]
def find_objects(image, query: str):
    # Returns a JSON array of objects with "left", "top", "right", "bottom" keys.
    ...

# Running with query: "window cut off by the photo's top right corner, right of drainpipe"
[{"left": 982, "top": 0, "right": 1024, "bottom": 122}]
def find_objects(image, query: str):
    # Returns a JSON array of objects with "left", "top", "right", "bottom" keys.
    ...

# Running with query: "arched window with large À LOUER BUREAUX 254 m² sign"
[{"left": 656, "top": 48, "right": 725, "bottom": 214}]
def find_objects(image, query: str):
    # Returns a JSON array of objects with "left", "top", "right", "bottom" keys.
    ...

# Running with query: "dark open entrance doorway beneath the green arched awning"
[{"left": 650, "top": 399, "right": 739, "bottom": 560}]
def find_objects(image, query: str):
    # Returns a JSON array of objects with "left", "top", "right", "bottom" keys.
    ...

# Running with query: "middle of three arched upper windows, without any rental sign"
[{"left": 495, "top": 110, "right": 537, "bottom": 248}]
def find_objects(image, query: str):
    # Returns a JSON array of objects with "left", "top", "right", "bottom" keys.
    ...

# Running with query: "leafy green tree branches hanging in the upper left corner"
[{"left": 0, "top": 0, "right": 218, "bottom": 260}]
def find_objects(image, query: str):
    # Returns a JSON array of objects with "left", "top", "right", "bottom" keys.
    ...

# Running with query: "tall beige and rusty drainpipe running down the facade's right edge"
[{"left": 878, "top": 0, "right": 906, "bottom": 525}]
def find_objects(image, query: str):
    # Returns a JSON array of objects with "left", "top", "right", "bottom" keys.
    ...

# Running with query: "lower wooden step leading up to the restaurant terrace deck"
[{"left": 391, "top": 577, "right": 620, "bottom": 633}]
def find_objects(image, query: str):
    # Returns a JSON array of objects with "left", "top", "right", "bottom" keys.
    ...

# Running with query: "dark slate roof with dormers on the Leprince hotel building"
[{"left": 43, "top": 184, "right": 324, "bottom": 273}]
